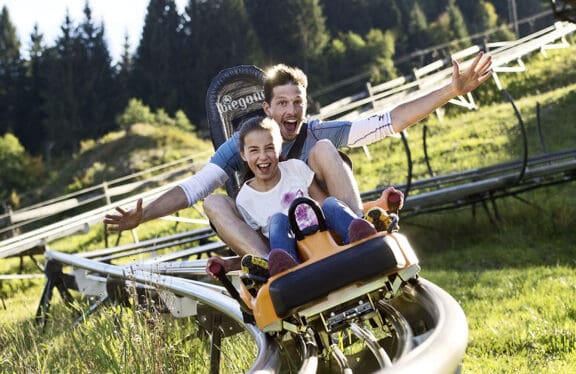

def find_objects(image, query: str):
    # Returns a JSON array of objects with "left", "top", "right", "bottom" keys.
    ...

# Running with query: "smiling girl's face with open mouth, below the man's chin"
[{"left": 240, "top": 130, "right": 280, "bottom": 183}]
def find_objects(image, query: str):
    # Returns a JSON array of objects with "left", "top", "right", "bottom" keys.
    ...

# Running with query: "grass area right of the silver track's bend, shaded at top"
[{"left": 403, "top": 185, "right": 576, "bottom": 373}]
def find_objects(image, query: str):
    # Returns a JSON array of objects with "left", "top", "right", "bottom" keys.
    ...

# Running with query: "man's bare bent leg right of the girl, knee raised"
[{"left": 308, "top": 139, "right": 362, "bottom": 217}]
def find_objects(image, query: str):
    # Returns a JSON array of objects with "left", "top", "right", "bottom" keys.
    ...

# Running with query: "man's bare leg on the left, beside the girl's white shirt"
[{"left": 204, "top": 194, "right": 270, "bottom": 260}]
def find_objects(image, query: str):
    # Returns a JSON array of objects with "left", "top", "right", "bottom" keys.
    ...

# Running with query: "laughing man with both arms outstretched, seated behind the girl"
[{"left": 104, "top": 53, "right": 492, "bottom": 270}]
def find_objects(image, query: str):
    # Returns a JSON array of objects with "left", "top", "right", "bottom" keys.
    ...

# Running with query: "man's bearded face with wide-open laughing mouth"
[{"left": 264, "top": 84, "right": 307, "bottom": 141}]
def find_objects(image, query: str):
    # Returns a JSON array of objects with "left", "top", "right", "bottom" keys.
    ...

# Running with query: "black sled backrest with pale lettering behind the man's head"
[{"left": 206, "top": 65, "right": 265, "bottom": 197}]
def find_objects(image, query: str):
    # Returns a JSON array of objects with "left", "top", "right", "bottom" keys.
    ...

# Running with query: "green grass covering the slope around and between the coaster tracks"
[{"left": 0, "top": 38, "right": 576, "bottom": 374}]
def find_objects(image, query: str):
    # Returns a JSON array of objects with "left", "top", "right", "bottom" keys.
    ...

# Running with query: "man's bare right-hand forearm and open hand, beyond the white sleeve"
[{"left": 390, "top": 52, "right": 492, "bottom": 133}]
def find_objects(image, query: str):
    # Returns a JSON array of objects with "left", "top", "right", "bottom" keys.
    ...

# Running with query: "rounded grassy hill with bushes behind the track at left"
[{"left": 23, "top": 123, "right": 214, "bottom": 205}]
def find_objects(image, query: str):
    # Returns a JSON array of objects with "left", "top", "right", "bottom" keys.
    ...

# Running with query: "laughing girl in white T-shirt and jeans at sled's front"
[{"left": 236, "top": 117, "right": 376, "bottom": 276}]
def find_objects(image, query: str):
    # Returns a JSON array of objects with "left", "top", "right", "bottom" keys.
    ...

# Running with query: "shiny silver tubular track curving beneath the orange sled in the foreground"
[{"left": 46, "top": 251, "right": 468, "bottom": 373}]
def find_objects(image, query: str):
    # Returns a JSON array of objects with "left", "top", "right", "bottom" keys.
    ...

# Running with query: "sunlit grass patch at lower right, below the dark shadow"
[{"left": 425, "top": 266, "right": 576, "bottom": 373}]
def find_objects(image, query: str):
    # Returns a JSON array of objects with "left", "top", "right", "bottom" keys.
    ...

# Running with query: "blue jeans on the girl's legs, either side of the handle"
[{"left": 269, "top": 196, "right": 358, "bottom": 262}]
